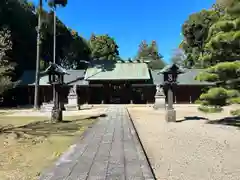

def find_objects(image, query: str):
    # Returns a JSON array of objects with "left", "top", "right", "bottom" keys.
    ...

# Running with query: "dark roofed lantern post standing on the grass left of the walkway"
[{"left": 41, "top": 63, "right": 68, "bottom": 122}]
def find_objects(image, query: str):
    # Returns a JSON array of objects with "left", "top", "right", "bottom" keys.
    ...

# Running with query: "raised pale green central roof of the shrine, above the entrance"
[{"left": 85, "top": 63, "right": 150, "bottom": 80}]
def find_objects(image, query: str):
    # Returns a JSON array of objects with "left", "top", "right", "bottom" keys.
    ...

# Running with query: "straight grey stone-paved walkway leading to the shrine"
[{"left": 40, "top": 106, "right": 154, "bottom": 180}]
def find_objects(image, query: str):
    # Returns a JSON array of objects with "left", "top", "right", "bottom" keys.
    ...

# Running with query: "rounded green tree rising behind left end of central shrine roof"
[{"left": 89, "top": 34, "right": 119, "bottom": 60}]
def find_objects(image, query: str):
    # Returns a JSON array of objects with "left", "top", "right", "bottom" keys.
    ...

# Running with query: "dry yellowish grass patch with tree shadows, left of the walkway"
[{"left": 0, "top": 114, "right": 97, "bottom": 180}]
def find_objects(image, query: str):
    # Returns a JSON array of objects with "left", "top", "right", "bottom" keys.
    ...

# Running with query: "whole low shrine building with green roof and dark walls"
[{"left": 3, "top": 61, "right": 214, "bottom": 105}]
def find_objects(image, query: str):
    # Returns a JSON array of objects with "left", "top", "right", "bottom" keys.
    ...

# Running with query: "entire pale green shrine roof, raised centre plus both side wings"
[{"left": 20, "top": 66, "right": 215, "bottom": 86}]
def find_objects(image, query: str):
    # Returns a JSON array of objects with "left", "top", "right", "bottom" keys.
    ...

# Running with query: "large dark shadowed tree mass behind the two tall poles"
[{"left": 0, "top": 0, "right": 90, "bottom": 80}]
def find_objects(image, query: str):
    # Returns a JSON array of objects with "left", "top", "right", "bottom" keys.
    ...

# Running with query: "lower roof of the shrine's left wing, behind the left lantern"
[{"left": 20, "top": 70, "right": 88, "bottom": 86}]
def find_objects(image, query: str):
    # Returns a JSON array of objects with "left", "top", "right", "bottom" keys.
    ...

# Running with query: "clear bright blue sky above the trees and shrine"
[{"left": 33, "top": 0, "right": 215, "bottom": 62}]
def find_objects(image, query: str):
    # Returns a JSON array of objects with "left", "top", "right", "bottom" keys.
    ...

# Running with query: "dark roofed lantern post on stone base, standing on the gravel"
[{"left": 160, "top": 64, "right": 184, "bottom": 122}]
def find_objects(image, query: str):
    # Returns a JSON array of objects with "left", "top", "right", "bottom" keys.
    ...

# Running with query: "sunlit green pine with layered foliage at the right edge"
[{"left": 181, "top": 0, "right": 240, "bottom": 111}]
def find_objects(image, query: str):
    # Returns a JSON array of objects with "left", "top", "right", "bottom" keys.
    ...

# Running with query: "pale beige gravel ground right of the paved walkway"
[{"left": 128, "top": 106, "right": 240, "bottom": 180}]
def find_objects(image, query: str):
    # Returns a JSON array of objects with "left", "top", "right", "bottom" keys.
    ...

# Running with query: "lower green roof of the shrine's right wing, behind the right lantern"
[{"left": 151, "top": 69, "right": 215, "bottom": 85}]
